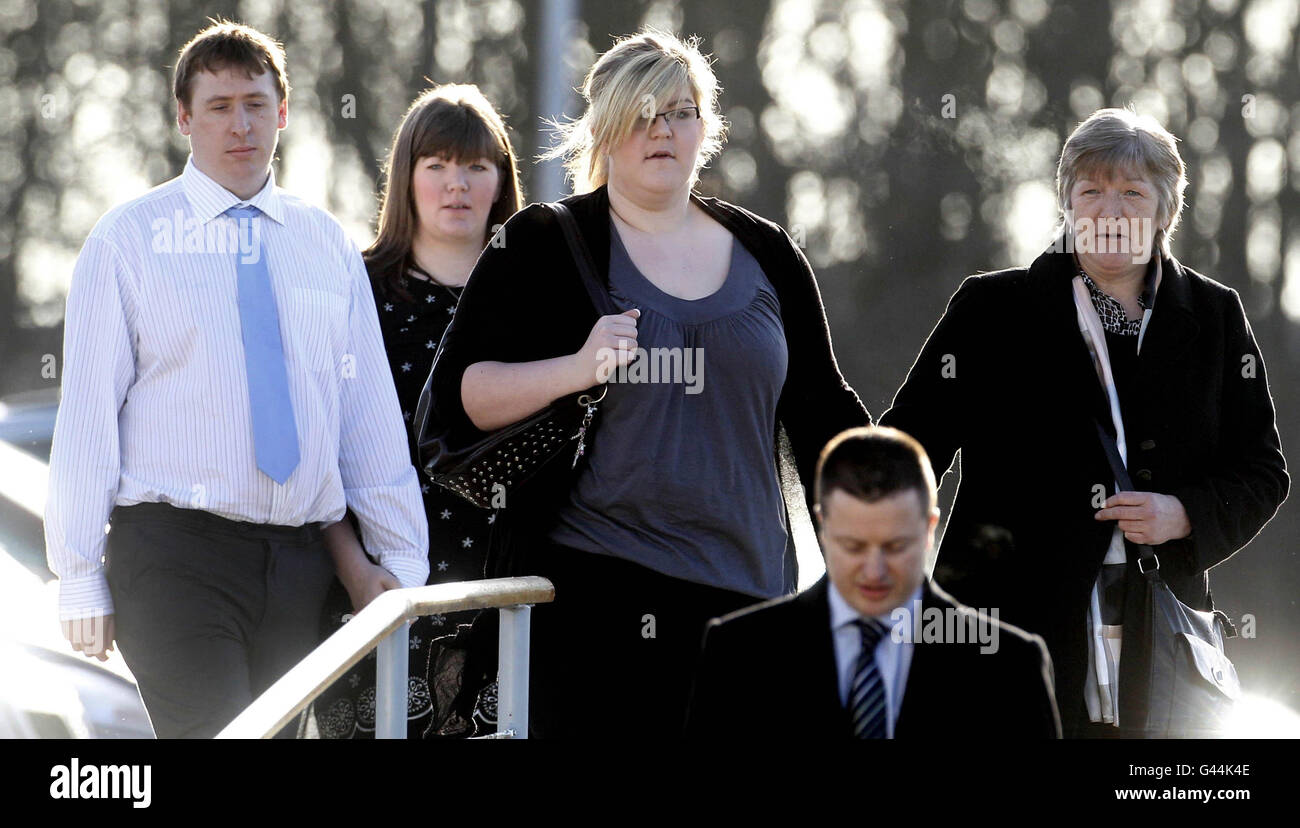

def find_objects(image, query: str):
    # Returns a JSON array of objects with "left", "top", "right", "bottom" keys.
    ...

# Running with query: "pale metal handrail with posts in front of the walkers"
[{"left": 217, "top": 576, "right": 555, "bottom": 738}]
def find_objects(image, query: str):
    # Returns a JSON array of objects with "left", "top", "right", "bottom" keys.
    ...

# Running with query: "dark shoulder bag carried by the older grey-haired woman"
[{"left": 1095, "top": 421, "right": 1242, "bottom": 737}]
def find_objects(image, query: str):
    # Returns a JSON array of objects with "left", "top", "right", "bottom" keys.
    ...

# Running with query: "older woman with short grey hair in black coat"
[{"left": 881, "top": 109, "right": 1290, "bottom": 737}]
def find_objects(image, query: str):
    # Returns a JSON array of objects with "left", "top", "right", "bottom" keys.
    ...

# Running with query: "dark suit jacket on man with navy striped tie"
[{"left": 686, "top": 577, "right": 1061, "bottom": 744}]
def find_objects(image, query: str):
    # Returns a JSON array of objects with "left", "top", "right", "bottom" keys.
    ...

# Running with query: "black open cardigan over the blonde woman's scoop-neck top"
[{"left": 415, "top": 187, "right": 871, "bottom": 575}]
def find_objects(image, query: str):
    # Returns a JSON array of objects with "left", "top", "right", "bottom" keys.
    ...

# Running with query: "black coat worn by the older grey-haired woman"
[{"left": 881, "top": 241, "right": 1290, "bottom": 734}]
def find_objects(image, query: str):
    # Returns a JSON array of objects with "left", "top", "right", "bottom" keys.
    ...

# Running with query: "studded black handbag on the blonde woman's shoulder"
[{"left": 416, "top": 203, "right": 619, "bottom": 508}]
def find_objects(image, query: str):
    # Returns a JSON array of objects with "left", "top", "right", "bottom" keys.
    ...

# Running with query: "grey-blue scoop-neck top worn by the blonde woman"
[{"left": 549, "top": 221, "right": 788, "bottom": 598}]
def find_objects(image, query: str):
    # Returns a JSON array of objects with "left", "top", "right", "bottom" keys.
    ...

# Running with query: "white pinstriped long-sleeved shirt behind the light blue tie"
[{"left": 46, "top": 157, "right": 429, "bottom": 619}]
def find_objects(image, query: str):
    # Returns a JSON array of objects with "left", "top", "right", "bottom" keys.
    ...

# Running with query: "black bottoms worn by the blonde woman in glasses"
[{"left": 528, "top": 546, "right": 762, "bottom": 741}]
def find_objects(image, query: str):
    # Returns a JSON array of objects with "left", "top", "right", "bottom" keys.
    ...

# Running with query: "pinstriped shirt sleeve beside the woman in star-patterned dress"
[{"left": 338, "top": 246, "right": 429, "bottom": 586}]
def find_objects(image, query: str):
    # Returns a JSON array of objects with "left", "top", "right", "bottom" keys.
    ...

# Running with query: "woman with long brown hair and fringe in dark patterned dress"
[{"left": 316, "top": 84, "right": 521, "bottom": 738}]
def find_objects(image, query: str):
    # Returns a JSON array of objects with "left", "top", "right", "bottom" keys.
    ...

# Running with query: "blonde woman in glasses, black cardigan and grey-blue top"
[{"left": 417, "top": 32, "right": 870, "bottom": 738}]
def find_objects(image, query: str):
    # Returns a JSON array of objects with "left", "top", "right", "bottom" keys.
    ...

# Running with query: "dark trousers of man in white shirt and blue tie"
[{"left": 105, "top": 503, "right": 334, "bottom": 738}]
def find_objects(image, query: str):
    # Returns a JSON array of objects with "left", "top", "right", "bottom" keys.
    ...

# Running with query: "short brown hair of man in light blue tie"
[{"left": 172, "top": 17, "right": 289, "bottom": 110}]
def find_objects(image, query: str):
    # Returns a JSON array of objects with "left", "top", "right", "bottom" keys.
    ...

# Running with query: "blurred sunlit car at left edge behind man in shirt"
[{"left": 0, "top": 389, "right": 153, "bottom": 738}]
